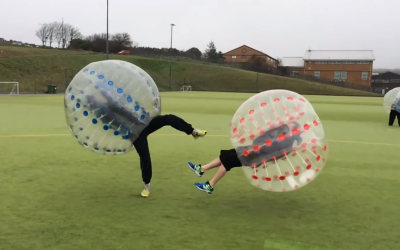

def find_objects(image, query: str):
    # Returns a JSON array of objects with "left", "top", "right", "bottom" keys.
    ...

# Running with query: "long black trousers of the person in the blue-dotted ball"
[{"left": 133, "top": 115, "right": 193, "bottom": 184}]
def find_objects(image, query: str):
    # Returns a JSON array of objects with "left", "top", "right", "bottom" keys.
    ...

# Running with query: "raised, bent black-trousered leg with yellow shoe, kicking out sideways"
[{"left": 145, "top": 115, "right": 207, "bottom": 139}]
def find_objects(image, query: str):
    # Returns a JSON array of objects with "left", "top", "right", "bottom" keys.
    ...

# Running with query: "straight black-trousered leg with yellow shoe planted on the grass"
[{"left": 133, "top": 136, "right": 152, "bottom": 197}]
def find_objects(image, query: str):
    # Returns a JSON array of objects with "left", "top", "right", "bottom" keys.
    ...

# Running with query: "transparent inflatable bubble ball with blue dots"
[{"left": 64, "top": 60, "right": 161, "bottom": 155}]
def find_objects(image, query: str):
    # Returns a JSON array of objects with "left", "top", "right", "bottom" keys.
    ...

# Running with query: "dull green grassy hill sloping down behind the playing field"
[{"left": 0, "top": 46, "right": 373, "bottom": 96}]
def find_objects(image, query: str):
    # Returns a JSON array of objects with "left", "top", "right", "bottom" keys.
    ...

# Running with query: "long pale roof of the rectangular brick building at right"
[{"left": 304, "top": 50, "right": 375, "bottom": 61}]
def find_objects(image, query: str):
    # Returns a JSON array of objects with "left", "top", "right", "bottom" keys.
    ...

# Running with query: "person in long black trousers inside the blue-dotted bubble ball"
[{"left": 87, "top": 92, "right": 207, "bottom": 198}]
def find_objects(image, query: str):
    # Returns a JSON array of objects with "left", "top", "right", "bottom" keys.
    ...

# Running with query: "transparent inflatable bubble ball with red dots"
[{"left": 230, "top": 90, "right": 328, "bottom": 192}]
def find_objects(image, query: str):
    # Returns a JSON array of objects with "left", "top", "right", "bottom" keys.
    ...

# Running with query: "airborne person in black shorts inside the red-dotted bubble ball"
[{"left": 188, "top": 122, "right": 302, "bottom": 194}]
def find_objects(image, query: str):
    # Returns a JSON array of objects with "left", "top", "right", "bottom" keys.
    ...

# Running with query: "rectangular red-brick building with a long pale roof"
[{"left": 282, "top": 50, "right": 375, "bottom": 86}]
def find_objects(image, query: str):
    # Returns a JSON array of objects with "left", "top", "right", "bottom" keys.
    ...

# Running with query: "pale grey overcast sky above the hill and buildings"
[{"left": 0, "top": 0, "right": 400, "bottom": 68}]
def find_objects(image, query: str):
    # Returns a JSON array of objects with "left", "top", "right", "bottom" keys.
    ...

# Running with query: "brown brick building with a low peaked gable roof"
[{"left": 224, "top": 45, "right": 278, "bottom": 68}]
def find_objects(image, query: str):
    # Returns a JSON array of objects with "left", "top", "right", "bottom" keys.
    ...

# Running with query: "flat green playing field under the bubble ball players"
[{"left": 0, "top": 92, "right": 400, "bottom": 250}]
